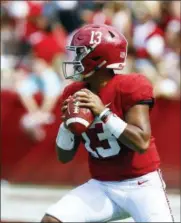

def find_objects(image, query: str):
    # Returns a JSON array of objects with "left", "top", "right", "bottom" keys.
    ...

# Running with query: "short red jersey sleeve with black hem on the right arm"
[{"left": 121, "top": 75, "right": 154, "bottom": 112}]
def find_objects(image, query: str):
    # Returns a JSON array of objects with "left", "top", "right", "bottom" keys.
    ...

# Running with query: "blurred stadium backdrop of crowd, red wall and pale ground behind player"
[{"left": 1, "top": 1, "right": 181, "bottom": 221}]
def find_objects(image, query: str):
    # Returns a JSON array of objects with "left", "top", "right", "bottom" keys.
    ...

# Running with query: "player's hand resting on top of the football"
[{"left": 74, "top": 89, "right": 105, "bottom": 116}]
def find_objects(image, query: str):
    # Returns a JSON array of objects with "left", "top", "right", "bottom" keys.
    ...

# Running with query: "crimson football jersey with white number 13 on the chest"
[{"left": 63, "top": 74, "right": 160, "bottom": 181}]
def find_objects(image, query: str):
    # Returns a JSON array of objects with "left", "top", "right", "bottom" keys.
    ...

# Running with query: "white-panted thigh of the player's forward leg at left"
[{"left": 46, "top": 179, "right": 118, "bottom": 222}]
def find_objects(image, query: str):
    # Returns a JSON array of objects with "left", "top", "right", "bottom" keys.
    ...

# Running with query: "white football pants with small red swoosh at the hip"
[{"left": 46, "top": 171, "right": 173, "bottom": 222}]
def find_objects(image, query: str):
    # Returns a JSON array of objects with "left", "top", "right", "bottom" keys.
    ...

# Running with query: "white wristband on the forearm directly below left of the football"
[{"left": 56, "top": 122, "right": 74, "bottom": 150}]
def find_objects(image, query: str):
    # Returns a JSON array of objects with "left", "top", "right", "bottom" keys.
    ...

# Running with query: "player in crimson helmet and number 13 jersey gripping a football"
[{"left": 42, "top": 25, "right": 173, "bottom": 222}]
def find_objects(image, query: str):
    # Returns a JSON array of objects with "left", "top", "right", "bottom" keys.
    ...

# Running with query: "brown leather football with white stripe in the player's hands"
[{"left": 65, "top": 97, "right": 94, "bottom": 135}]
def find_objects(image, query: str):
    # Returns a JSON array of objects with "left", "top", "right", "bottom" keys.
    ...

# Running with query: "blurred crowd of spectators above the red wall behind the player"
[{"left": 1, "top": 0, "right": 181, "bottom": 141}]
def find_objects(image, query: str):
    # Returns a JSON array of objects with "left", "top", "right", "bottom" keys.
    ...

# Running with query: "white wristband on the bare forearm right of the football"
[{"left": 105, "top": 112, "right": 127, "bottom": 139}]
